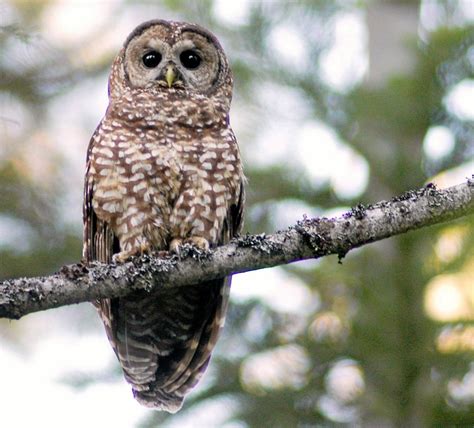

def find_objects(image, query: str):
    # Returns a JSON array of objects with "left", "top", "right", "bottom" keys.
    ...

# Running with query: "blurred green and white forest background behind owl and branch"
[{"left": 0, "top": 0, "right": 474, "bottom": 428}]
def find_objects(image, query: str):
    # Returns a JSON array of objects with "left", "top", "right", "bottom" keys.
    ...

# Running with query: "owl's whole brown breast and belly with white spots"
[{"left": 90, "top": 98, "right": 240, "bottom": 252}]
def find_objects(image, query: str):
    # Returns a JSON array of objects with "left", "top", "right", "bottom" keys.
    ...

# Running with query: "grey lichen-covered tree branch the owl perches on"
[{"left": 0, "top": 180, "right": 474, "bottom": 319}]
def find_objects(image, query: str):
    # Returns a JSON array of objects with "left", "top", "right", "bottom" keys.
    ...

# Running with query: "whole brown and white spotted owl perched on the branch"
[{"left": 83, "top": 20, "right": 245, "bottom": 413}]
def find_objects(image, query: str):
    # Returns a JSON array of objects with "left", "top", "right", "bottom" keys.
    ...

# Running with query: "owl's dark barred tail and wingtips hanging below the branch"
[{"left": 99, "top": 278, "right": 230, "bottom": 413}]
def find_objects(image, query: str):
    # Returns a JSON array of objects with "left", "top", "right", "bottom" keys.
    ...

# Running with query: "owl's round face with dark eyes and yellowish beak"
[{"left": 123, "top": 21, "right": 227, "bottom": 93}]
